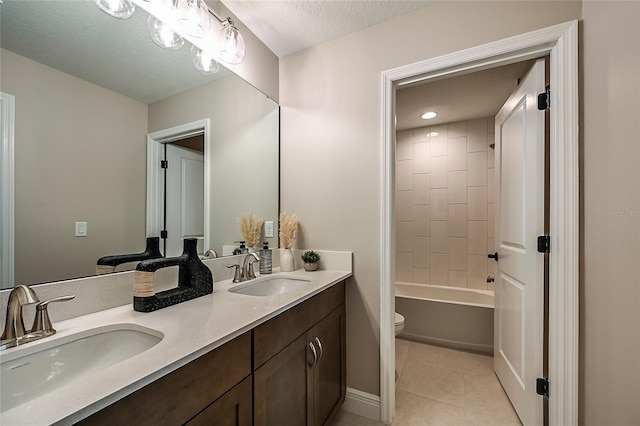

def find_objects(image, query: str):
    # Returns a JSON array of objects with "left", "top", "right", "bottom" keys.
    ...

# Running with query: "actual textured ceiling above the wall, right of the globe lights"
[{"left": 221, "top": 0, "right": 430, "bottom": 57}]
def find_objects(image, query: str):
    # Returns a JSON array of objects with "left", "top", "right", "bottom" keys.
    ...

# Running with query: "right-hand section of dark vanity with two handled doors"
[{"left": 254, "top": 283, "right": 346, "bottom": 426}]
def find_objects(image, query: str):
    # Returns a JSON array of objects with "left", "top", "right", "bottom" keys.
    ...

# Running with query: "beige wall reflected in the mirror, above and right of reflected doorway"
[{"left": 149, "top": 76, "right": 278, "bottom": 254}]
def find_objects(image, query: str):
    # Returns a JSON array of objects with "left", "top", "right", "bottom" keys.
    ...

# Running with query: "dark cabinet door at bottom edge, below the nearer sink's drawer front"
[{"left": 187, "top": 377, "right": 253, "bottom": 426}]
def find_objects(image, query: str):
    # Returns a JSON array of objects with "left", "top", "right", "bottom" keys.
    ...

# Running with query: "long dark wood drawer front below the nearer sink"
[{"left": 79, "top": 332, "right": 251, "bottom": 426}]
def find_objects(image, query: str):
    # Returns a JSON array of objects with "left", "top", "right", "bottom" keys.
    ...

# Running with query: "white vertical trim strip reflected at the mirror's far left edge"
[{"left": 0, "top": 92, "right": 16, "bottom": 288}]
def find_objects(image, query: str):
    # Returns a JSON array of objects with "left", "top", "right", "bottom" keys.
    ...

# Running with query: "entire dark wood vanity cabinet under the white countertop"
[{"left": 79, "top": 282, "right": 346, "bottom": 426}]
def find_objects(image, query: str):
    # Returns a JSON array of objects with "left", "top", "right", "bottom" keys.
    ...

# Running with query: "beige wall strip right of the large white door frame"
[{"left": 580, "top": 1, "right": 640, "bottom": 425}]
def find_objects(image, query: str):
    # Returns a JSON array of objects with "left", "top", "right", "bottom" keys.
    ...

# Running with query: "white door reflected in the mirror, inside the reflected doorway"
[{"left": 164, "top": 143, "right": 204, "bottom": 257}]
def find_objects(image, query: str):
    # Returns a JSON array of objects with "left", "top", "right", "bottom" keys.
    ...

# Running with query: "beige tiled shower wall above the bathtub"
[{"left": 396, "top": 117, "right": 495, "bottom": 290}]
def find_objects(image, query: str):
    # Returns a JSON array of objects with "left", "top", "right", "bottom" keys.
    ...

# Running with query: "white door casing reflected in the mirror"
[{"left": 146, "top": 118, "right": 211, "bottom": 250}]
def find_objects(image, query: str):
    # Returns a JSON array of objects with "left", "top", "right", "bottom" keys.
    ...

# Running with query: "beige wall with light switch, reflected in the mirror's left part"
[{"left": 1, "top": 50, "right": 147, "bottom": 284}]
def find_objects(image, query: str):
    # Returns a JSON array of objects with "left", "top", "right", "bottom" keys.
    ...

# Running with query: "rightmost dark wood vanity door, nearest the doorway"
[{"left": 312, "top": 305, "right": 346, "bottom": 426}]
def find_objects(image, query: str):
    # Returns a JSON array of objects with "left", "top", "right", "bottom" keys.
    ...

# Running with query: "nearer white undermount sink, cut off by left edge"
[{"left": 0, "top": 328, "right": 162, "bottom": 411}]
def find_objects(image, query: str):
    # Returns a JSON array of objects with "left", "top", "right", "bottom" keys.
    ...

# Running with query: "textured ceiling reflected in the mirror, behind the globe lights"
[{"left": 0, "top": 0, "right": 229, "bottom": 104}]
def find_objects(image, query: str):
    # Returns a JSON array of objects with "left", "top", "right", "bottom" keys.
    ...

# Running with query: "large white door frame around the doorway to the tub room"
[{"left": 380, "top": 21, "right": 579, "bottom": 425}]
